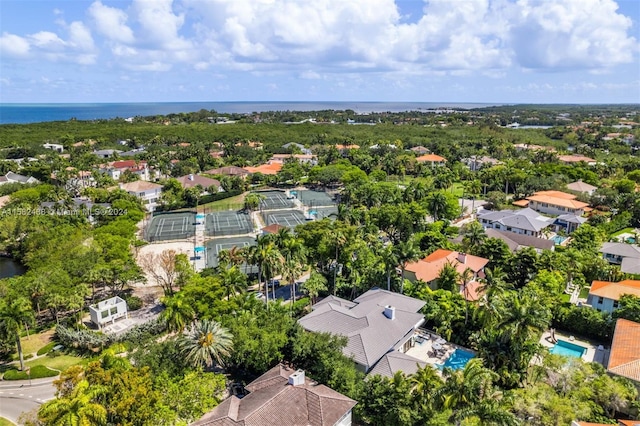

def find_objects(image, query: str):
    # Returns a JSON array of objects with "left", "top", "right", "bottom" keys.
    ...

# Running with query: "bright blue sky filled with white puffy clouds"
[{"left": 0, "top": 0, "right": 640, "bottom": 103}]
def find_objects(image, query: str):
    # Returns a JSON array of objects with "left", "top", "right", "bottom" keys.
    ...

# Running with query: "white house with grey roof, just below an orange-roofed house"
[{"left": 478, "top": 208, "right": 553, "bottom": 238}]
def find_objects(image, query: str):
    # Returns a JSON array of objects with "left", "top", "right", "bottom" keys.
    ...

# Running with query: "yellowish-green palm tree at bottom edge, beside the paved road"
[{"left": 38, "top": 380, "right": 107, "bottom": 426}]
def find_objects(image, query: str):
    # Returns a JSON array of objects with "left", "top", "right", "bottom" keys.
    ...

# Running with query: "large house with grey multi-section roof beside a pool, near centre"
[{"left": 298, "top": 288, "right": 425, "bottom": 373}]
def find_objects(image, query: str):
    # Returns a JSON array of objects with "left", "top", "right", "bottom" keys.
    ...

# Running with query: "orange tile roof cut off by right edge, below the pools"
[{"left": 607, "top": 318, "right": 640, "bottom": 384}]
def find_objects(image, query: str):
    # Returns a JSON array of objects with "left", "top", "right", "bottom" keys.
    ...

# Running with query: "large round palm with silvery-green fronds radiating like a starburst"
[{"left": 179, "top": 320, "right": 233, "bottom": 368}]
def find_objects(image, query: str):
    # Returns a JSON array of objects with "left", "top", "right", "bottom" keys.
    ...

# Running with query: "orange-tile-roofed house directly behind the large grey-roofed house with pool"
[{"left": 405, "top": 249, "right": 489, "bottom": 301}]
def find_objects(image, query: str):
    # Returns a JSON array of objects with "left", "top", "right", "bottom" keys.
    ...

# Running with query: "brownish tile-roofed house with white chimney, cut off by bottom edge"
[{"left": 192, "top": 364, "right": 357, "bottom": 426}]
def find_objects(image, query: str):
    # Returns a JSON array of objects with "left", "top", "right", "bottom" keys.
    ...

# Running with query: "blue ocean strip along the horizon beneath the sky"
[{"left": 0, "top": 102, "right": 496, "bottom": 124}]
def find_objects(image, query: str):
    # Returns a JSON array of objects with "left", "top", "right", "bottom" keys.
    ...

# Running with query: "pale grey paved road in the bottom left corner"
[{"left": 0, "top": 378, "right": 56, "bottom": 424}]
